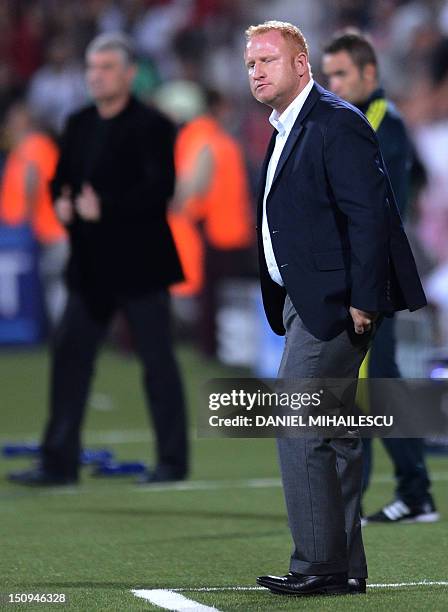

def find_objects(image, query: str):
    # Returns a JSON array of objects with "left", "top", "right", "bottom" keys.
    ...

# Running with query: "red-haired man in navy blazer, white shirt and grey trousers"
[{"left": 245, "top": 21, "right": 426, "bottom": 595}]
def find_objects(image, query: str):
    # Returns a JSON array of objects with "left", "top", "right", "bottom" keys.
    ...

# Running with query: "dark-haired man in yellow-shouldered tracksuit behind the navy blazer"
[{"left": 323, "top": 30, "right": 439, "bottom": 523}]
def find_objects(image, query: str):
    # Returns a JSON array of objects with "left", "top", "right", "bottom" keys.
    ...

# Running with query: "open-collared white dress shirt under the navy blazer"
[{"left": 262, "top": 79, "right": 314, "bottom": 286}]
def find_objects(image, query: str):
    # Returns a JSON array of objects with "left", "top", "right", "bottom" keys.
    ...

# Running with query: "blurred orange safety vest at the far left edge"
[{"left": 0, "top": 133, "right": 66, "bottom": 244}]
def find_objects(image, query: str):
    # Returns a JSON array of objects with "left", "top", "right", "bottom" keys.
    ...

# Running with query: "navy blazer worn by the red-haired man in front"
[{"left": 257, "top": 84, "right": 426, "bottom": 340}]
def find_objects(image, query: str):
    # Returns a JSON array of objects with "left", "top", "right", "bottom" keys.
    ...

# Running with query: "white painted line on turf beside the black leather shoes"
[{"left": 131, "top": 580, "right": 448, "bottom": 612}]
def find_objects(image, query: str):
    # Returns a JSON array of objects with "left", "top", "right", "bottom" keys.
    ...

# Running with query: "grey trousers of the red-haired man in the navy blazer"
[{"left": 277, "top": 297, "right": 373, "bottom": 578}]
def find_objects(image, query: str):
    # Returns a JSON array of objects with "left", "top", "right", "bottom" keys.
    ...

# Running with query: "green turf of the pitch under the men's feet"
[{"left": 0, "top": 347, "right": 448, "bottom": 612}]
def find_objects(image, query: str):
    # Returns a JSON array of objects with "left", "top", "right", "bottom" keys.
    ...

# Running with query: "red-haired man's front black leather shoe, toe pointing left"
[{"left": 257, "top": 572, "right": 349, "bottom": 595}]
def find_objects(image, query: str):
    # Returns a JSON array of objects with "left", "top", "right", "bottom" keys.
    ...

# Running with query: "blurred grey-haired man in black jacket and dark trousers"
[{"left": 11, "top": 34, "right": 188, "bottom": 485}]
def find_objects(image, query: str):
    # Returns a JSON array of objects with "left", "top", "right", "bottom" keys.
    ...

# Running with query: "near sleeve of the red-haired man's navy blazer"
[{"left": 324, "top": 108, "right": 395, "bottom": 312}]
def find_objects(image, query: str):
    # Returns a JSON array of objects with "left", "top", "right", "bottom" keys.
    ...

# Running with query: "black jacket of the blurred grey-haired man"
[{"left": 52, "top": 98, "right": 182, "bottom": 301}]
